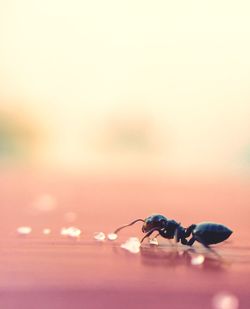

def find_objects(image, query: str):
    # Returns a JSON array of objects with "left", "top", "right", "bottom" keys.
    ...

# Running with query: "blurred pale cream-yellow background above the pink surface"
[{"left": 0, "top": 0, "right": 250, "bottom": 180}]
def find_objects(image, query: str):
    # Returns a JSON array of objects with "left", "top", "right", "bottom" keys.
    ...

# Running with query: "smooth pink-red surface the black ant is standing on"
[{"left": 0, "top": 173, "right": 250, "bottom": 309}]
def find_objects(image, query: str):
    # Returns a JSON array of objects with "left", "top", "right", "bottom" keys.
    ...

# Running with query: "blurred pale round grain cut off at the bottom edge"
[{"left": 212, "top": 292, "right": 239, "bottom": 309}]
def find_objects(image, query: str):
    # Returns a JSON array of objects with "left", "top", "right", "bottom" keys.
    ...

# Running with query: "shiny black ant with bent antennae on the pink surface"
[{"left": 114, "top": 214, "right": 232, "bottom": 248}]
